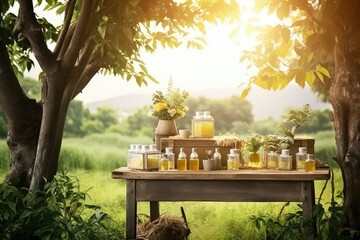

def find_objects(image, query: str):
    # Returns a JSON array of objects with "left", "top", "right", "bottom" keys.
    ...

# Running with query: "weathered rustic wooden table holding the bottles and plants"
[{"left": 112, "top": 167, "right": 330, "bottom": 239}]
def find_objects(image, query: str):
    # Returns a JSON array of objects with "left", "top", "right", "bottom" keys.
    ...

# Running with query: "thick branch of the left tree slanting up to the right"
[{"left": 62, "top": 0, "right": 97, "bottom": 69}]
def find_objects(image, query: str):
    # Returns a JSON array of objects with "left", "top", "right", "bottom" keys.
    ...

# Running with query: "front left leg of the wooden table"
[{"left": 126, "top": 180, "right": 137, "bottom": 239}]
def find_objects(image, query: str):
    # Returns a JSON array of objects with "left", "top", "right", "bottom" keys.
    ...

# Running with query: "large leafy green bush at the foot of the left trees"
[{"left": 0, "top": 174, "right": 124, "bottom": 239}]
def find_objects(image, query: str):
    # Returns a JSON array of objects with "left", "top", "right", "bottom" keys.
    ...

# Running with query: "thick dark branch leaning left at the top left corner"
[{"left": 14, "top": 0, "right": 55, "bottom": 72}]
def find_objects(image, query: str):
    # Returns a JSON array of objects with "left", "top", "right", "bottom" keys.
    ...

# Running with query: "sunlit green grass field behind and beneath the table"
[{"left": 0, "top": 132, "right": 342, "bottom": 240}]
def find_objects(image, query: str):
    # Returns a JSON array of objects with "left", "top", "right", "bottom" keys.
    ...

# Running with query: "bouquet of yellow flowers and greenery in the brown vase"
[{"left": 149, "top": 80, "right": 189, "bottom": 120}]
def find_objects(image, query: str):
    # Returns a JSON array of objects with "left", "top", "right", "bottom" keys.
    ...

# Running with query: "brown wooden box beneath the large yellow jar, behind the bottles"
[{"left": 160, "top": 137, "right": 233, "bottom": 169}]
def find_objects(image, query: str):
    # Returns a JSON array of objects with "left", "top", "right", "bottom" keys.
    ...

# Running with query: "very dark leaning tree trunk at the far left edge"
[{"left": 0, "top": 39, "right": 42, "bottom": 188}]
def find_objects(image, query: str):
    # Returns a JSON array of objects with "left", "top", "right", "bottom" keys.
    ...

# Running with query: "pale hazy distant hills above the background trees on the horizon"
[{"left": 86, "top": 85, "right": 331, "bottom": 120}]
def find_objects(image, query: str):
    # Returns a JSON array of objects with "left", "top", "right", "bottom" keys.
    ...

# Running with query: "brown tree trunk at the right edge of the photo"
[{"left": 329, "top": 53, "right": 360, "bottom": 230}]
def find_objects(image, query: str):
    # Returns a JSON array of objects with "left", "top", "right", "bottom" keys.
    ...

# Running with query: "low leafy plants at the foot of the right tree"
[{"left": 250, "top": 170, "right": 360, "bottom": 240}]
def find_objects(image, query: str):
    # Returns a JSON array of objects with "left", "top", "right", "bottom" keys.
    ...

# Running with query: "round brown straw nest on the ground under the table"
[{"left": 137, "top": 215, "right": 190, "bottom": 240}]
